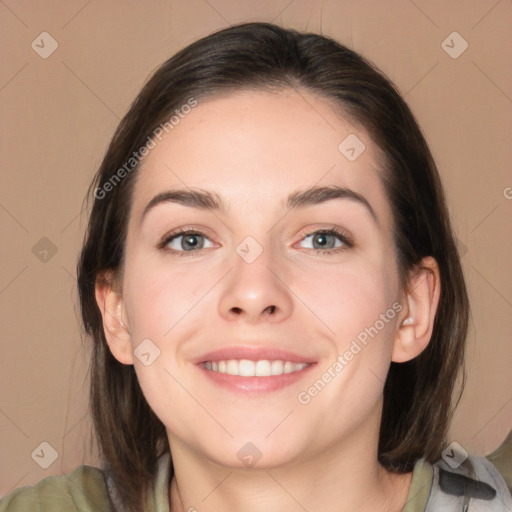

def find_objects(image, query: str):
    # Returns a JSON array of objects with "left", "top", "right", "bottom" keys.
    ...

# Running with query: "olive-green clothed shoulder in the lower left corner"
[{"left": 0, "top": 465, "right": 112, "bottom": 512}]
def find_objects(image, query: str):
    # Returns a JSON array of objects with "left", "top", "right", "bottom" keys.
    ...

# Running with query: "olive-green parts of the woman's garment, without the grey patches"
[{"left": 0, "top": 453, "right": 512, "bottom": 512}]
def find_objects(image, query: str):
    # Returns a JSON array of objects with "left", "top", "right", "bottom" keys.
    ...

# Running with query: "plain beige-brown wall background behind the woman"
[{"left": 0, "top": 0, "right": 512, "bottom": 495}]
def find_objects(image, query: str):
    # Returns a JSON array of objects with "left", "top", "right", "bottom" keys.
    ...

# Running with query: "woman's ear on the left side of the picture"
[{"left": 94, "top": 270, "right": 133, "bottom": 364}]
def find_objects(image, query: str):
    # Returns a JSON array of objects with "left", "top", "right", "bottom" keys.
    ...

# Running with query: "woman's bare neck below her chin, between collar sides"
[{"left": 170, "top": 420, "right": 412, "bottom": 512}]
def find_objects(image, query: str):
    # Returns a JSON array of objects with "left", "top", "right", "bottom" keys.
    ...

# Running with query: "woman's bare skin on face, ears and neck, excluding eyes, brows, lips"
[{"left": 96, "top": 90, "right": 440, "bottom": 512}]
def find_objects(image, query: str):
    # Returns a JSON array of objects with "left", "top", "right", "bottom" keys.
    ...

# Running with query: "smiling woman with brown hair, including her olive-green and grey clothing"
[{"left": 0, "top": 23, "right": 512, "bottom": 512}]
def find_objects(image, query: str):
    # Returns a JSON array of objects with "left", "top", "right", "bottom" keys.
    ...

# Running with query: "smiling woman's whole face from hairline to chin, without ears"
[{"left": 115, "top": 90, "right": 403, "bottom": 467}]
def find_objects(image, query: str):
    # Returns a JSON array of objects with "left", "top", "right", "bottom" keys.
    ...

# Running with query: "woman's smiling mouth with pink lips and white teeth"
[{"left": 196, "top": 347, "right": 317, "bottom": 396}]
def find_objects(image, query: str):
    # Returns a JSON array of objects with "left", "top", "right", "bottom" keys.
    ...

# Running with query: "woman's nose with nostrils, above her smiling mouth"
[{"left": 219, "top": 244, "right": 293, "bottom": 324}]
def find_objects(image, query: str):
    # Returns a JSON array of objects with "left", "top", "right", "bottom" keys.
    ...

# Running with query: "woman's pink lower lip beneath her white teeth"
[{"left": 197, "top": 363, "right": 316, "bottom": 395}]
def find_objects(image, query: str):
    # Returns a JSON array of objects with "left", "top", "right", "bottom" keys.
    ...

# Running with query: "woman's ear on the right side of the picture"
[{"left": 391, "top": 256, "right": 441, "bottom": 363}]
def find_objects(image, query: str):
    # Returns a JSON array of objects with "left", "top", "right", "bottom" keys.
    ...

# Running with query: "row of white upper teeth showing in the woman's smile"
[{"left": 204, "top": 359, "right": 309, "bottom": 377}]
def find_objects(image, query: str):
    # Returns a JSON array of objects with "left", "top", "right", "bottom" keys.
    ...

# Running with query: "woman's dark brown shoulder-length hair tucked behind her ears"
[{"left": 78, "top": 23, "right": 469, "bottom": 510}]
